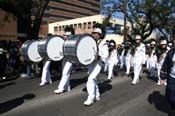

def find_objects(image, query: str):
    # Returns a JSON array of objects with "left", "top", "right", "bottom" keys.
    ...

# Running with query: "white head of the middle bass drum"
[{"left": 46, "top": 36, "right": 64, "bottom": 61}]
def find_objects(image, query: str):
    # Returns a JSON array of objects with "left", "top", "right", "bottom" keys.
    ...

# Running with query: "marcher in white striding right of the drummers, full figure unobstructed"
[{"left": 131, "top": 35, "right": 145, "bottom": 85}]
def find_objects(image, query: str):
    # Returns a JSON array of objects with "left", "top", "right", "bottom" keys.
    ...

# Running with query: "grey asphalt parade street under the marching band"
[{"left": 0, "top": 71, "right": 170, "bottom": 116}]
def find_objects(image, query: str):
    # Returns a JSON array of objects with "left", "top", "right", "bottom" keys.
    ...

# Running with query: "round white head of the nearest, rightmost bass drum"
[{"left": 76, "top": 36, "right": 98, "bottom": 65}]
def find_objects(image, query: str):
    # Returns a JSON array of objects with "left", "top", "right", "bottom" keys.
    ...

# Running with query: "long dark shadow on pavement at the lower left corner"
[{"left": 0, "top": 94, "right": 35, "bottom": 114}]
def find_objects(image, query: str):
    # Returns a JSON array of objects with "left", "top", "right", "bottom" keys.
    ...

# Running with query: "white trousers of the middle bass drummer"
[{"left": 58, "top": 61, "right": 72, "bottom": 90}]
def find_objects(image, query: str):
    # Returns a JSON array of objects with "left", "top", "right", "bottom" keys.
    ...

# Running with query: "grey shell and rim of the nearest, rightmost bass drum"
[{"left": 63, "top": 34, "right": 98, "bottom": 65}]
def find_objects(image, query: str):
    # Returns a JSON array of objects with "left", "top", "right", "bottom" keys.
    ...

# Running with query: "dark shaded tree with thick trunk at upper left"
[{"left": 0, "top": 0, "right": 49, "bottom": 39}]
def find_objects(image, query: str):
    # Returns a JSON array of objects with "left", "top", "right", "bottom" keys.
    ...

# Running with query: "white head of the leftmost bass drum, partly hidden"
[{"left": 27, "top": 41, "right": 42, "bottom": 62}]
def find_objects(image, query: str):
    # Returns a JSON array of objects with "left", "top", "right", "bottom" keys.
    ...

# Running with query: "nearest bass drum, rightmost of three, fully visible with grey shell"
[{"left": 64, "top": 34, "right": 98, "bottom": 65}]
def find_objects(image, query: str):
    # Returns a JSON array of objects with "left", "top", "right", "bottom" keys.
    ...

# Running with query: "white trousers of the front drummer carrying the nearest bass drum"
[{"left": 86, "top": 61, "right": 102, "bottom": 101}]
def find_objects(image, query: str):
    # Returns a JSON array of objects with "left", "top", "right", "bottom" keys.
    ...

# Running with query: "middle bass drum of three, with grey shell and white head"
[{"left": 38, "top": 35, "right": 64, "bottom": 61}]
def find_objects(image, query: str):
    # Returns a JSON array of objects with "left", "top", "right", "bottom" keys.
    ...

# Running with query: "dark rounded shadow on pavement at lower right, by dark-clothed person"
[{"left": 148, "top": 91, "right": 171, "bottom": 116}]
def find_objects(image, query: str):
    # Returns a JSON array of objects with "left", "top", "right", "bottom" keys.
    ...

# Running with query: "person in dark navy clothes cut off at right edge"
[{"left": 160, "top": 48, "right": 175, "bottom": 116}]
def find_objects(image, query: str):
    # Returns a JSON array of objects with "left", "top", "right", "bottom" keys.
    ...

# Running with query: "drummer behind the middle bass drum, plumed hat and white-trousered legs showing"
[{"left": 54, "top": 27, "right": 74, "bottom": 94}]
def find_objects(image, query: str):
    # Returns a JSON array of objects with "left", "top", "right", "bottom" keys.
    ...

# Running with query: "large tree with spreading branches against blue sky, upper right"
[{"left": 101, "top": 0, "right": 175, "bottom": 40}]
